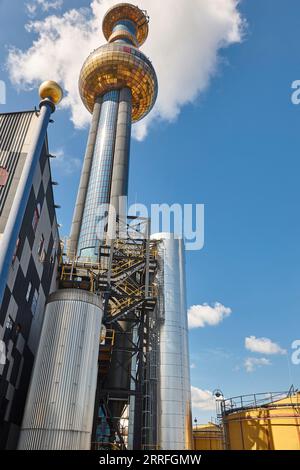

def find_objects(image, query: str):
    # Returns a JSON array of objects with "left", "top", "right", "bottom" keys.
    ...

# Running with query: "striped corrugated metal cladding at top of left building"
[{"left": 0, "top": 111, "right": 35, "bottom": 215}]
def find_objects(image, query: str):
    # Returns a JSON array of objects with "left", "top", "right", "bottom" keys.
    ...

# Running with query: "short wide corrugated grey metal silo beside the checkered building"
[{"left": 18, "top": 289, "right": 103, "bottom": 450}]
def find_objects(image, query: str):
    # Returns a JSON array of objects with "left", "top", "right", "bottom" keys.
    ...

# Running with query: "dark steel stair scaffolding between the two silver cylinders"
[{"left": 60, "top": 217, "right": 159, "bottom": 450}]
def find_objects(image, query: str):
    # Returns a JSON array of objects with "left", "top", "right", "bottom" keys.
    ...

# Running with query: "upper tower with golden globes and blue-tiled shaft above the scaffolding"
[{"left": 69, "top": 3, "right": 158, "bottom": 259}]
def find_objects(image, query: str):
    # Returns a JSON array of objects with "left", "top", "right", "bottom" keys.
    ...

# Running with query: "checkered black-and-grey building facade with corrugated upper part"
[{"left": 0, "top": 111, "right": 60, "bottom": 449}]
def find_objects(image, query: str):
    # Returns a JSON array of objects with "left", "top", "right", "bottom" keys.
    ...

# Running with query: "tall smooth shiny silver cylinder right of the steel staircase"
[{"left": 152, "top": 233, "right": 193, "bottom": 450}]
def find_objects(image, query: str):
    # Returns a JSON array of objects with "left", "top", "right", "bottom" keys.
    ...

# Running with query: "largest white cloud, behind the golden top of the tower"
[{"left": 7, "top": 0, "right": 244, "bottom": 140}]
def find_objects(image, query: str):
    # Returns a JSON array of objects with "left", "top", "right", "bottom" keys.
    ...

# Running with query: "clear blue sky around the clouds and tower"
[{"left": 0, "top": 0, "right": 300, "bottom": 422}]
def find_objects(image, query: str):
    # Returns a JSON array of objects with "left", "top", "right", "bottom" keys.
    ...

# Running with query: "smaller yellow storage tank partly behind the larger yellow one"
[{"left": 193, "top": 423, "right": 224, "bottom": 450}]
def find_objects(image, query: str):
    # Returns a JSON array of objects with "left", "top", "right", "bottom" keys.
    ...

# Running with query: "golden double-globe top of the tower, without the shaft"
[{"left": 79, "top": 3, "right": 158, "bottom": 122}]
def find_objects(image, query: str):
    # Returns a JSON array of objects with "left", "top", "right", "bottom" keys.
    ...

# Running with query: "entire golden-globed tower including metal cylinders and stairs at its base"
[{"left": 15, "top": 3, "right": 192, "bottom": 450}]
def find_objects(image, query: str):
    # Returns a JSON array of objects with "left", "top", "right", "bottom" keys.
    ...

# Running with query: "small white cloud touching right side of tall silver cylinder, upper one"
[{"left": 188, "top": 302, "right": 232, "bottom": 329}]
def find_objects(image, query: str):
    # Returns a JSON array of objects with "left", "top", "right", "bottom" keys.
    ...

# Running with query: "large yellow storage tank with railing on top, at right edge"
[{"left": 221, "top": 391, "right": 300, "bottom": 450}]
